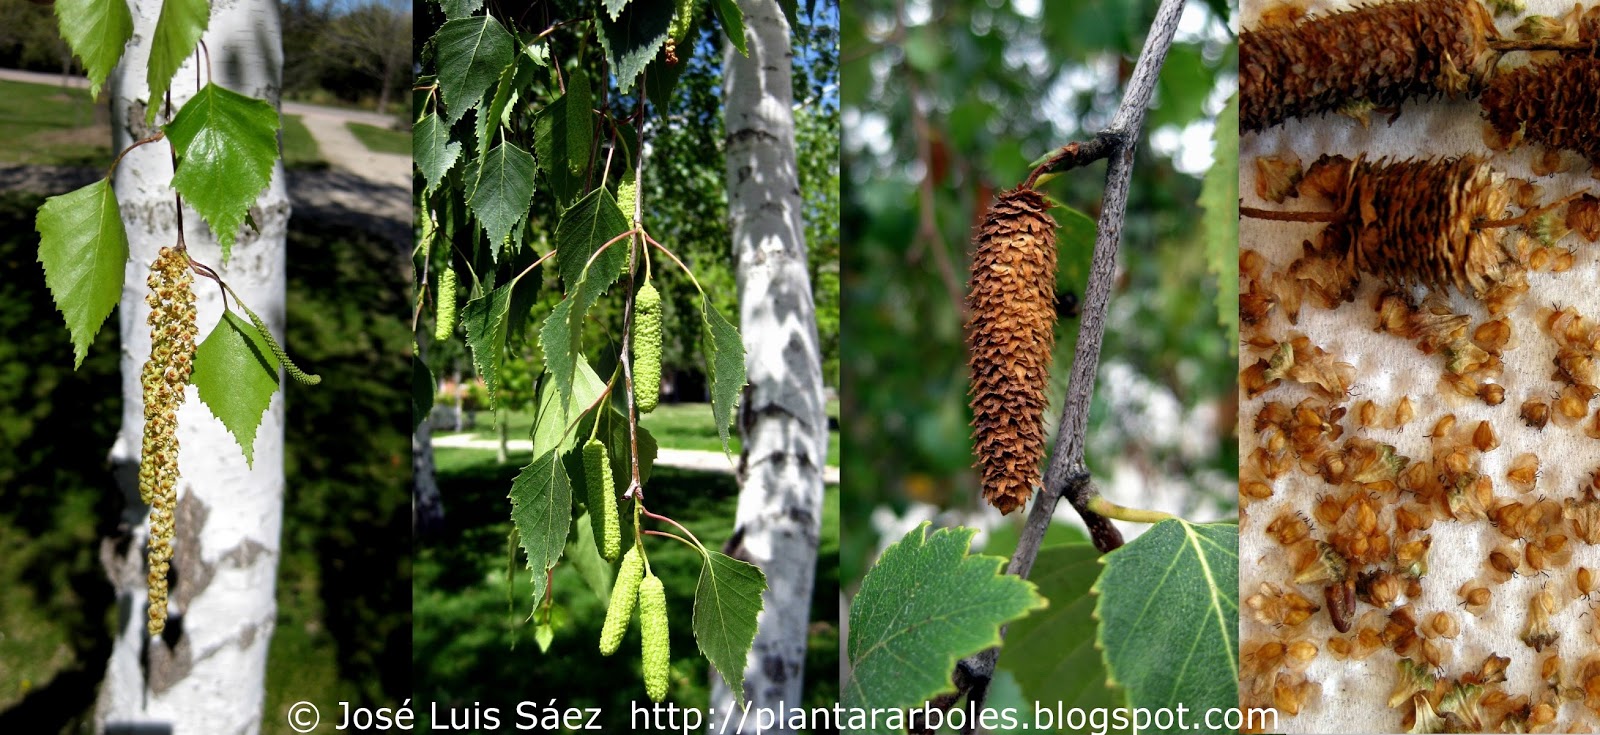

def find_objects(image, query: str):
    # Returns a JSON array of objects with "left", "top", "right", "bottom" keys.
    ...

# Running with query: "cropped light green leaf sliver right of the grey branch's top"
[{"left": 1200, "top": 91, "right": 1238, "bottom": 354}]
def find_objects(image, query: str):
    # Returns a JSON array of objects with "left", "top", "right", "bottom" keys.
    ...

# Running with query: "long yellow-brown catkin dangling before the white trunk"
[{"left": 139, "top": 248, "right": 200, "bottom": 636}]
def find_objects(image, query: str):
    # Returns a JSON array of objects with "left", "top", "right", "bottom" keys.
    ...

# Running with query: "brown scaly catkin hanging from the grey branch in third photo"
[{"left": 966, "top": 189, "right": 1056, "bottom": 514}]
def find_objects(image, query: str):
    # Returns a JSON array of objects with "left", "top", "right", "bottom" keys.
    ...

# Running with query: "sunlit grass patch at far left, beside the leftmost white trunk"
[{"left": 0, "top": 82, "right": 112, "bottom": 167}]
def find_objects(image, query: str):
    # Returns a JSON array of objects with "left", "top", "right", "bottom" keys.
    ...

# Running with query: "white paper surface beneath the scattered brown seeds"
[{"left": 1240, "top": 0, "right": 1600, "bottom": 733}]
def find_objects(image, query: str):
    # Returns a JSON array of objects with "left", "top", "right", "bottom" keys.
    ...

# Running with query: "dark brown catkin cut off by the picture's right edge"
[{"left": 1478, "top": 56, "right": 1600, "bottom": 167}]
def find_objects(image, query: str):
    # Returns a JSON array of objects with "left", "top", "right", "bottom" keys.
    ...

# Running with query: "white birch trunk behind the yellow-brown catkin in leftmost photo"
[{"left": 96, "top": 0, "right": 291, "bottom": 735}]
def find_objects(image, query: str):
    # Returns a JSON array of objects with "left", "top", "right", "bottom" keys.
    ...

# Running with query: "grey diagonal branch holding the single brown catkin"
[{"left": 950, "top": 0, "right": 1184, "bottom": 726}]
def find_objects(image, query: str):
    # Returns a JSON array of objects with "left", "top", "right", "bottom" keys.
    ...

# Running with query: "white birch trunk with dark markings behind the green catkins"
[{"left": 710, "top": 0, "right": 827, "bottom": 723}]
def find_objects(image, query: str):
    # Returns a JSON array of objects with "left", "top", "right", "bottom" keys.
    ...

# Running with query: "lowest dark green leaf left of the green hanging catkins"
[{"left": 510, "top": 450, "right": 573, "bottom": 605}]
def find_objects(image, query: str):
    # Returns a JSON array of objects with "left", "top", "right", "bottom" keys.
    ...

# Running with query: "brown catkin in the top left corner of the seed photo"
[{"left": 1238, "top": 0, "right": 1498, "bottom": 133}]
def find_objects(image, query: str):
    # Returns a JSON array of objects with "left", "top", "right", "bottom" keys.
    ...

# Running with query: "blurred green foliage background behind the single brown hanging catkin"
[{"left": 840, "top": 0, "right": 1237, "bottom": 586}]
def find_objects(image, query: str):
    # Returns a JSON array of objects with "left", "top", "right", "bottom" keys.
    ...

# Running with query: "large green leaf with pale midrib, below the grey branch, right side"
[{"left": 1093, "top": 519, "right": 1238, "bottom": 730}]
